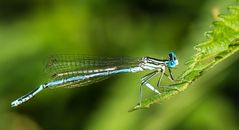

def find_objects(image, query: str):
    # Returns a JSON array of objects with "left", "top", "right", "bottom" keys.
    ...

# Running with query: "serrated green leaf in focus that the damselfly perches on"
[{"left": 130, "top": 4, "right": 239, "bottom": 111}]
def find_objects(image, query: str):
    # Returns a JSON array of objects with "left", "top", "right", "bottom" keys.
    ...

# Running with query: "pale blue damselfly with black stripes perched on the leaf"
[{"left": 11, "top": 52, "right": 178, "bottom": 107}]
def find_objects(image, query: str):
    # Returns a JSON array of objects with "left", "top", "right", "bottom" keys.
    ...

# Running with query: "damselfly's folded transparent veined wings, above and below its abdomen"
[{"left": 46, "top": 55, "right": 140, "bottom": 88}]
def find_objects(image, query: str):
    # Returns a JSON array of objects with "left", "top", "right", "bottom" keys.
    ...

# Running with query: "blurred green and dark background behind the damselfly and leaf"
[{"left": 0, "top": 0, "right": 239, "bottom": 130}]
